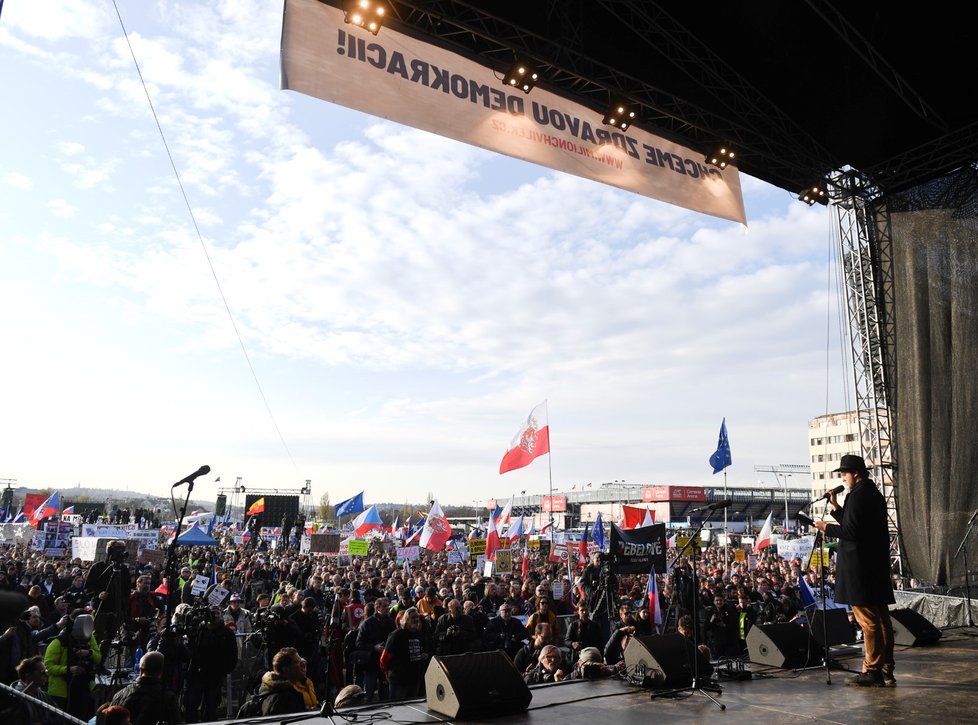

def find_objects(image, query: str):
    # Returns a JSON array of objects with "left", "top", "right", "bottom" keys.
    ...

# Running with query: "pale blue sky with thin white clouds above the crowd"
[{"left": 0, "top": 0, "right": 849, "bottom": 504}]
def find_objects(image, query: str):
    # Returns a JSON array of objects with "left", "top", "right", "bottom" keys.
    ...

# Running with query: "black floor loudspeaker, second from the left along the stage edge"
[{"left": 623, "top": 634, "right": 713, "bottom": 687}]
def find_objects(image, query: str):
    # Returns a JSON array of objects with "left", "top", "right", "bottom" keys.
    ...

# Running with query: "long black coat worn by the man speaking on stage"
[{"left": 825, "top": 479, "right": 894, "bottom": 606}]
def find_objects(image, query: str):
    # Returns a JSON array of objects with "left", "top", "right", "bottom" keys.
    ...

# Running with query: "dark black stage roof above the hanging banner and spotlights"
[{"left": 329, "top": 0, "right": 978, "bottom": 195}]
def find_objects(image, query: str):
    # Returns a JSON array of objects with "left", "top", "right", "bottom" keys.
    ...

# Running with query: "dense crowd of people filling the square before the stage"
[{"left": 0, "top": 490, "right": 868, "bottom": 725}]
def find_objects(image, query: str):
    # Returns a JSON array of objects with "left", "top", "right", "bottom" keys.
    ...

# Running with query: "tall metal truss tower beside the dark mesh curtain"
[{"left": 829, "top": 171, "right": 904, "bottom": 577}]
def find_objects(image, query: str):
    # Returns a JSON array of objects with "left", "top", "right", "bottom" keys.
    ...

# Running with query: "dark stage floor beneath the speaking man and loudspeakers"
[{"left": 219, "top": 628, "right": 978, "bottom": 725}]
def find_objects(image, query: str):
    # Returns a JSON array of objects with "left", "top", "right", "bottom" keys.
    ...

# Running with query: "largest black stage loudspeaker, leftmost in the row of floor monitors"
[{"left": 424, "top": 650, "right": 533, "bottom": 718}]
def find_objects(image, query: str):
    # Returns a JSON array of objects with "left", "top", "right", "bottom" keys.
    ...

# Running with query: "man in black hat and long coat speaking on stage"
[{"left": 815, "top": 455, "right": 896, "bottom": 687}]
